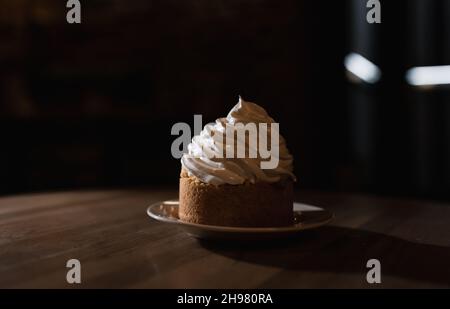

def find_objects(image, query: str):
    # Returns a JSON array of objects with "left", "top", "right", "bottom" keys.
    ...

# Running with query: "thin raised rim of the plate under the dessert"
[{"left": 146, "top": 199, "right": 335, "bottom": 234}]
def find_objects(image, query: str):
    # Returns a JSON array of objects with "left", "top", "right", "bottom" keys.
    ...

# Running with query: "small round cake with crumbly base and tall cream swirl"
[{"left": 179, "top": 98, "right": 296, "bottom": 227}]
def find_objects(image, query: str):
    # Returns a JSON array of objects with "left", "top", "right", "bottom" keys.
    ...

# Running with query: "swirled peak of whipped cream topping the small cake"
[{"left": 181, "top": 98, "right": 296, "bottom": 185}]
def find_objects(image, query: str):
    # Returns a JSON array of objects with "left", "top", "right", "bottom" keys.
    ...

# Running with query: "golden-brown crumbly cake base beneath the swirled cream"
[{"left": 179, "top": 170, "right": 294, "bottom": 227}]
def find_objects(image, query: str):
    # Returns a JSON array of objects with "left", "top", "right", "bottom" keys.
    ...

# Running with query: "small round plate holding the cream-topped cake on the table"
[{"left": 147, "top": 200, "right": 334, "bottom": 240}]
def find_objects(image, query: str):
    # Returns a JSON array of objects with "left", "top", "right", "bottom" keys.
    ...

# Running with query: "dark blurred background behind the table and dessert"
[{"left": 0, "top": 0, "right": 450, "bottom": 200}]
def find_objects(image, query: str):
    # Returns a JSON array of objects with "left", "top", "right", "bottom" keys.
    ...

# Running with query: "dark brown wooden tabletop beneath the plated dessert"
[{"left": 0, "top": 189, "right": 450, "bottom": 288}]
